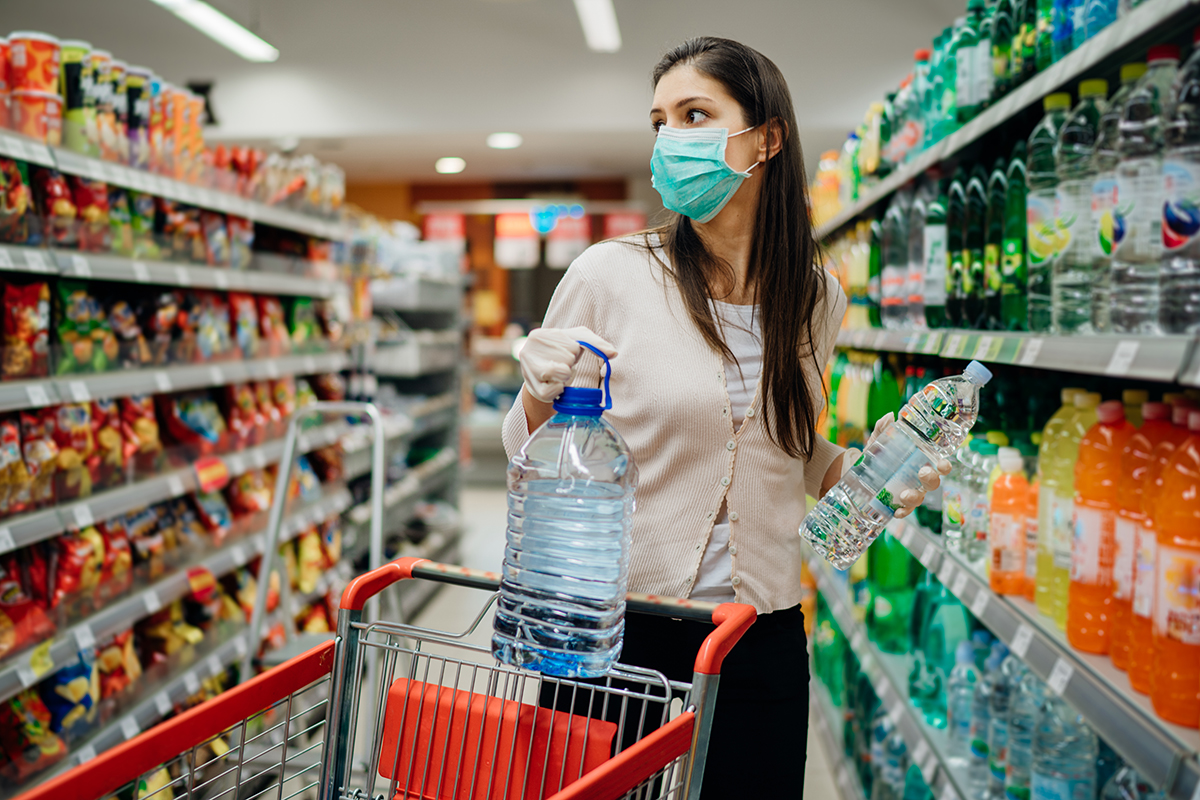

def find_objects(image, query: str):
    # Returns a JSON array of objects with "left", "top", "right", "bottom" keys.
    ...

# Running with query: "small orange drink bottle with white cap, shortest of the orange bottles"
[{"left": 988, "top": 447, "right": 1030, "bottom": 595}]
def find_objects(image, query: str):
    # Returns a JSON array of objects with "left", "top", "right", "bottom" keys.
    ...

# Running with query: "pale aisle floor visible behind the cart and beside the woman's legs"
[{"left": 414, "top": 488, "right": 838, "bottom": 800}]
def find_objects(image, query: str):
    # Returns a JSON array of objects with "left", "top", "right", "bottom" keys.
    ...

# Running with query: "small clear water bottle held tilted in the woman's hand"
[{"left": 800, "top": 361, "right": 991, "bottom": 570}]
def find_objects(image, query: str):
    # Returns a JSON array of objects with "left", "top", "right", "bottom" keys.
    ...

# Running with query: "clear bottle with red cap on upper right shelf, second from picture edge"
[{"left": 1111, "top": 44, "right": 1180, "bottom": 335}]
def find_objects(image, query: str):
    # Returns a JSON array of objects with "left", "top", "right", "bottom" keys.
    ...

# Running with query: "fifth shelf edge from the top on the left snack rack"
[{"left": 0, "top": 487, "right": 350, "bottom": 710}]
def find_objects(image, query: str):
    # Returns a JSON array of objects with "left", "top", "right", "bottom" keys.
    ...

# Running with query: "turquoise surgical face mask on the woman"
[{"left": 650, "top": 125, "right": 758, "bottom": 222}]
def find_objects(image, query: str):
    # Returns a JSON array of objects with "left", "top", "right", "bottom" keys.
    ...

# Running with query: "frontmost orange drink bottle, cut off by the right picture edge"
[{"left": 1150, "top": 411, "right": 1200, "bottom": 728}]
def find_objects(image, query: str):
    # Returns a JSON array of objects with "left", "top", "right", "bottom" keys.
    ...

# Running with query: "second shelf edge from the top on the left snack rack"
[{"left": 45, "top": 247, "right": 349, "bottom": 297}]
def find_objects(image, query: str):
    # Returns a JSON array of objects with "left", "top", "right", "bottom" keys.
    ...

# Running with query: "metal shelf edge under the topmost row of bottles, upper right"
[{"left": 815, "top": 0, "right": 1200, "bottom": 240}]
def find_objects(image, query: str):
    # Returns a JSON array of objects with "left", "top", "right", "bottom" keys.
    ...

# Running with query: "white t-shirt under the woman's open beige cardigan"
[{"left": 691, "top": 300, "right": 762, "bottom": 603}]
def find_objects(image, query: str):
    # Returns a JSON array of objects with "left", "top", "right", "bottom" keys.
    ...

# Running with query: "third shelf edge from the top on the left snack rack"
[{"left": 0, "top": 350, "right": 348, "bottom": 411}]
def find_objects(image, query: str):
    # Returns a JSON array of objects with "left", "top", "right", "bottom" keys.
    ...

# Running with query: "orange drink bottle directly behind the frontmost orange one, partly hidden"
[{"left": 1129, "top": 396, "right": 1193, "bottom": 694}]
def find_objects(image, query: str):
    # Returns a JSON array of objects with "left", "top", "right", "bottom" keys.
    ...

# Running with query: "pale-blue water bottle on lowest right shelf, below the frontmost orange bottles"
[{"left": 1031, "top": 692, "right": 1099, "bottom": 800}]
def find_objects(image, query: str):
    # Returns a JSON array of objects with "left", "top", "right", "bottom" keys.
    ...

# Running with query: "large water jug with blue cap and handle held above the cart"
[{"left": 492, "top": 342, "right": 637, "bottom": 678}]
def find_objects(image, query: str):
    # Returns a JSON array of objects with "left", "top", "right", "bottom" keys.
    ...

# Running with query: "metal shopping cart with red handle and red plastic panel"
[{"left": 20, "top": 559, "right": 755, "bottom": 800}]
